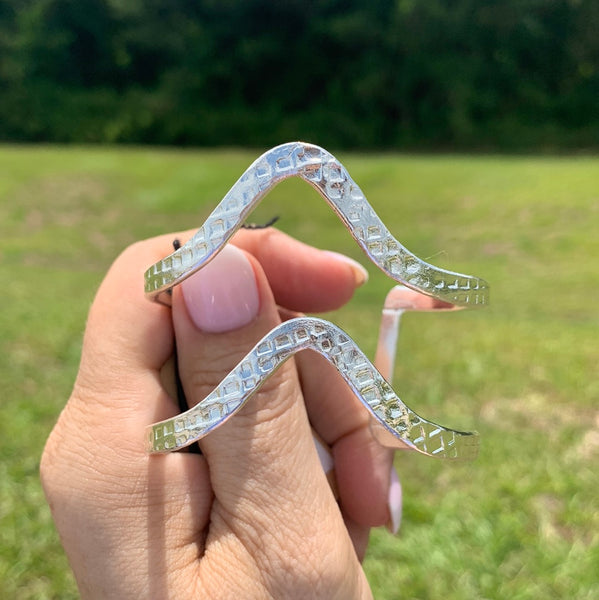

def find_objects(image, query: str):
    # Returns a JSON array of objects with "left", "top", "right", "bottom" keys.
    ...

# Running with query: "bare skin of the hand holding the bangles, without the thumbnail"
[{"left": 41, "top": 229, "right": 392, "bottom": 600}]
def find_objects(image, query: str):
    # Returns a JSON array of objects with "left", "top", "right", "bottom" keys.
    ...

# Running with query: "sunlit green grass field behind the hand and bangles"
[{"left": 0, "top": 146, "right": 599, "bottom": 600}]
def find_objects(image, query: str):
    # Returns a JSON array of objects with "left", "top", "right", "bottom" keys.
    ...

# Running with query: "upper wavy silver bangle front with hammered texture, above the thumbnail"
[{"left": 145, "top": 142, "right": 488, "bottom": 307}]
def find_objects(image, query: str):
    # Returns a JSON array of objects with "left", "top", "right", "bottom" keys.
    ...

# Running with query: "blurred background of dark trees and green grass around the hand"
[{"left": 0, "top": 0, "right": 599, "bottom": 600}]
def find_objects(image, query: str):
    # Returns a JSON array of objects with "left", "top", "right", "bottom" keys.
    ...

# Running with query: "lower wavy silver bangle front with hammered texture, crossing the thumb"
[{"left": 148, "top": 317, "right": 478, "bottom": 459}]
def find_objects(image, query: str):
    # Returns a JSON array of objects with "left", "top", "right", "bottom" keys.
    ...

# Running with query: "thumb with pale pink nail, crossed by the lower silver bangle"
[{"left": 172, "top": 246, "right": 370, "bottom": 598}]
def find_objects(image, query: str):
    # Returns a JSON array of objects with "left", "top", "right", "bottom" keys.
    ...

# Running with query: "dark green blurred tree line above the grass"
[{"left": 0, "top": 0, "right": 599, "bottom": 150}]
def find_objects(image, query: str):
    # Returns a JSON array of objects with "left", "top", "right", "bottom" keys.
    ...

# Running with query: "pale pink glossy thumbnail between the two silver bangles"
[{"left": 181, "top": 245, "right": 260, "bottom": 333}]
